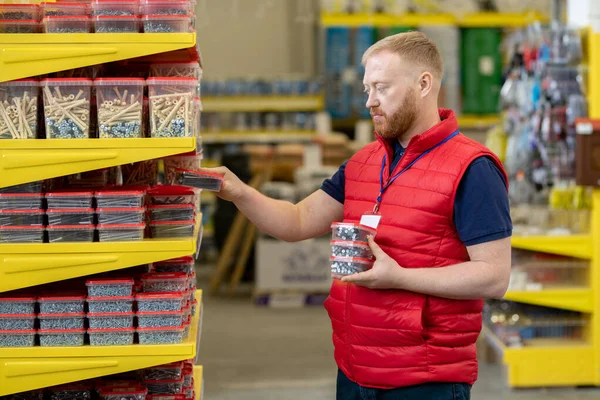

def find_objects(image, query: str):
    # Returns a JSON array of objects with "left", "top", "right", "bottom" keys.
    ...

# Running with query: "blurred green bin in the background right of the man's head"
[{"left": 461, "top": 28, "right": 502, "bottom": 114}]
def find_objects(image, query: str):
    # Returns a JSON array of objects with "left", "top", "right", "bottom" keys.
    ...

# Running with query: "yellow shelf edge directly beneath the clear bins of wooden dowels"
[{"left": 0, "top": 138, "right": 196, "bottom": 187}]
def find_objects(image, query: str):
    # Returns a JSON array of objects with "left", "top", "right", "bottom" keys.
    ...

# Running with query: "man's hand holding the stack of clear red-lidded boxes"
[{"left": 334, "top": 236, "right": 404, "bottom": 289}]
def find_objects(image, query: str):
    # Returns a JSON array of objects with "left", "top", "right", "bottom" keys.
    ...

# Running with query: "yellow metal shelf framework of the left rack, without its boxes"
[{"left": 0, "top": 16, "right": 203, "bottom": 399}]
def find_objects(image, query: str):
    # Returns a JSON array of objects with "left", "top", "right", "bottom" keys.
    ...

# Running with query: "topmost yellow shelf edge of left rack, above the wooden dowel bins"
[{"left": 0, "top": 33, "right": 196, "bottom": 82}]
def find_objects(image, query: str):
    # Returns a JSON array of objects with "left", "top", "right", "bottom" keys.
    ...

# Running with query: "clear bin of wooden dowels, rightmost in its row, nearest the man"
[{"left": 146, "top": 77, "right": 198, "bottom": 137}]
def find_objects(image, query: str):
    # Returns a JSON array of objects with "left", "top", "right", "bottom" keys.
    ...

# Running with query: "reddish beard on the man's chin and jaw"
[{"left": 371, "top": 90, "right": 417, "bottom": 139}]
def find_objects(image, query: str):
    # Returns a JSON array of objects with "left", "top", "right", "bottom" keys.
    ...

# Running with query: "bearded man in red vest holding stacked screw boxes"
[{"left": 202, "top": 32, "right": 512, "bottom": 400}]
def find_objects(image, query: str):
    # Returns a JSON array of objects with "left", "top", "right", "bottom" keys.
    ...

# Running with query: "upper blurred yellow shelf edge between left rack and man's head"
[{"left": 202, "top": 95, "right": 325, "bottom": 112}]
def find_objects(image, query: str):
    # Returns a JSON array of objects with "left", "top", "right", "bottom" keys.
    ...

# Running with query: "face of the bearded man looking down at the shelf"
[{"left": 363, "top": 51, "right": 418, "bottom": 139}]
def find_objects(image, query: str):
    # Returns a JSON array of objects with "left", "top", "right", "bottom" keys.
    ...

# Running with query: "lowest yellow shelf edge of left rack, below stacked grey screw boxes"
[{"left": 0, "top": 290, "right": 202, "bottom": 396}]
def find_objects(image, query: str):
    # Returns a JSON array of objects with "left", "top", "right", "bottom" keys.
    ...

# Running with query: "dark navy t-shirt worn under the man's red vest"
[{"left": 321, "top": 141, "right": 512, "bottom": 246}]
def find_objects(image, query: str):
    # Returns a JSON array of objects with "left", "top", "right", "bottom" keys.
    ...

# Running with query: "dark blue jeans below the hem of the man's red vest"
[{"left": 336, "top": 370, "right": 471, "bottom": 400}]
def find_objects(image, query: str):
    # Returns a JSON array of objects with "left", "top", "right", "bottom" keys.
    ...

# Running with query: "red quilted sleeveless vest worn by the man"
[{"left": 325, "top": 109, "right": 506, "bottom": 389}]
